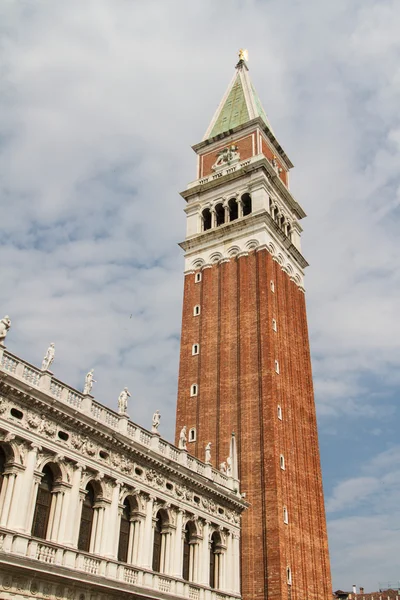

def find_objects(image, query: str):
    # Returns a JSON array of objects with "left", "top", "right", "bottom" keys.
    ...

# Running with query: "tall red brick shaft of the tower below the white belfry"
[{"left": 176, "top": 250, "right": 332, "bottom": 600}]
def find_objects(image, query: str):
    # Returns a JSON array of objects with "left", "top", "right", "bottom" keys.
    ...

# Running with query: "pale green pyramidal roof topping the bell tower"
[{"left": 203, "top": 60, "right": 273, "bottom": 140}]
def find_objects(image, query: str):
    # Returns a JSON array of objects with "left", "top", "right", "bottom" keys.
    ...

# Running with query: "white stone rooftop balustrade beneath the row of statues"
[{"left": 0, "top": 348, "right": 239, "bottom": 495}]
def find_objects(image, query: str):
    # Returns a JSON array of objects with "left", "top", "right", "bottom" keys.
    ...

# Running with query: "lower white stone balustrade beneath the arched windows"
[{"left": 0, "top": 529, "right": 240, "bottom": 600}]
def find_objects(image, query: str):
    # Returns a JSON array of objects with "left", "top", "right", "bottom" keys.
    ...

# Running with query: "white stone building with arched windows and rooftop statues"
[{"left": 0, "top": 335, "right": 246, "bottom": 600}]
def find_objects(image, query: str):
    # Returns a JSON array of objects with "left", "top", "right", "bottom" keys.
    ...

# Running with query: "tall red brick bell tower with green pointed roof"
[{"left": 176, "top": 51, "right": 332, "bottom": 600}]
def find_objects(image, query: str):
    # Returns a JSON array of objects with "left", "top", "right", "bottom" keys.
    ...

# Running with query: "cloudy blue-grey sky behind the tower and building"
[{"left": 0, "top": 0, "right": 400, "bottom": 591}]
